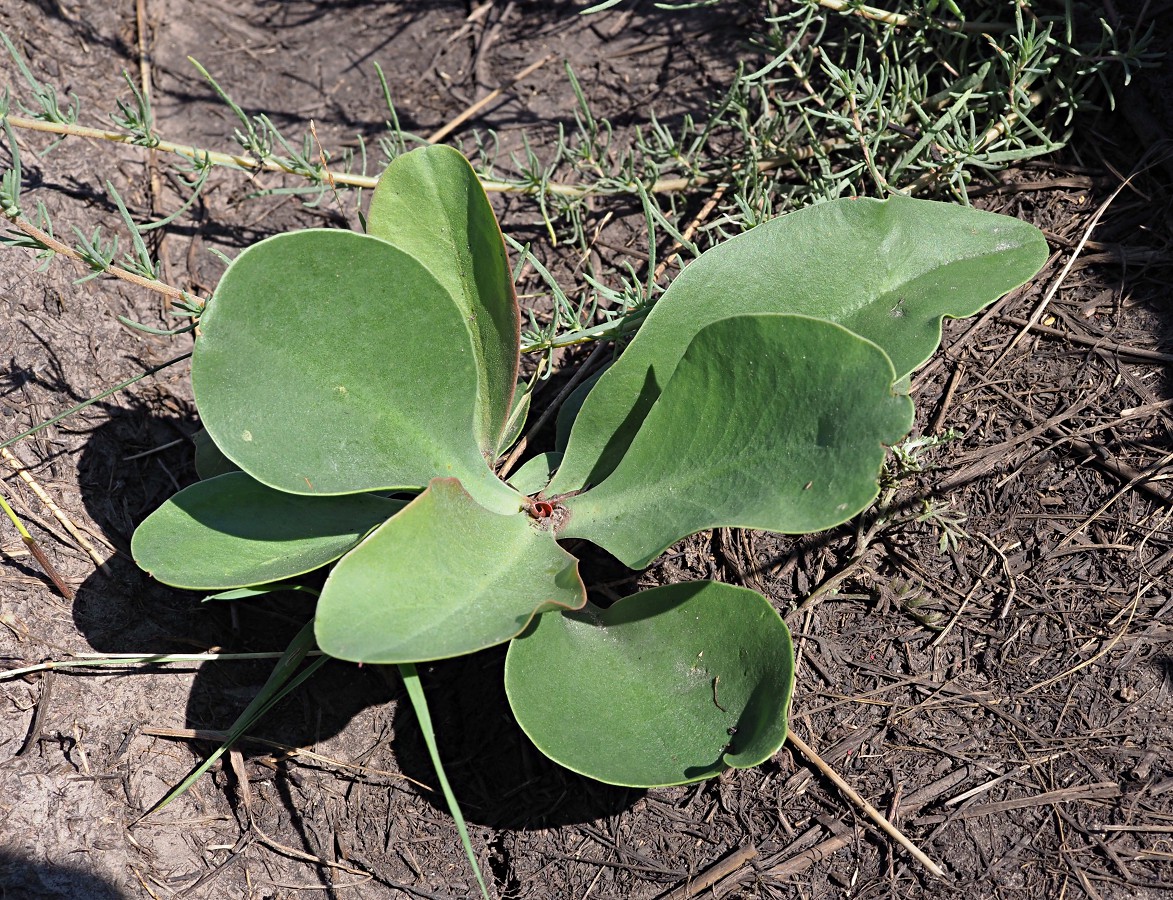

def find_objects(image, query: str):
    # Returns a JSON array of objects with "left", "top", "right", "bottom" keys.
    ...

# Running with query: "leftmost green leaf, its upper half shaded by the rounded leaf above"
[{"left": 130, "top": 472, "right": 404, "bottom": 590}]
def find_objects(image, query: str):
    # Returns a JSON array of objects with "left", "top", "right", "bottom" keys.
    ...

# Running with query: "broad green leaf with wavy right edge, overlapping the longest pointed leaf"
[{"left": 560, "top": 313, "right": 913, "bottom": 568}]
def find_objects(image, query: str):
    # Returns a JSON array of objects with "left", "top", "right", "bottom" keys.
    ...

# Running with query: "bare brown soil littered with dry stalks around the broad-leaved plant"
[{"left": 0, "top": 0, "right": 1173, "bottom": 900}]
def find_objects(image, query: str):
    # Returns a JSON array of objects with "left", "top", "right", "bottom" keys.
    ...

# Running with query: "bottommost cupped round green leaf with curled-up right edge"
[{"left": 506, "top": 582, "right": 794, "bottom": 787}]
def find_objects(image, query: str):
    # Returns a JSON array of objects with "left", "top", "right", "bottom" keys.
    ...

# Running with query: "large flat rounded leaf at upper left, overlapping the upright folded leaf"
[{"left": 191, "top": 229, "right": 517, "bottom": 509}]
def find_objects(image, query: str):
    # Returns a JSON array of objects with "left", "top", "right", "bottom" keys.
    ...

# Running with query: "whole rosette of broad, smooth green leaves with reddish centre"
[{"left": 133, "top": 147, "right": 1046, "bottom": 786}]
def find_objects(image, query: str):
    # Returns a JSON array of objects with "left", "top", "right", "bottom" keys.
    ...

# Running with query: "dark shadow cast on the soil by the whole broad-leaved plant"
[{"left": 73, "top": 407, "right": 643, "bottom": 828}]
